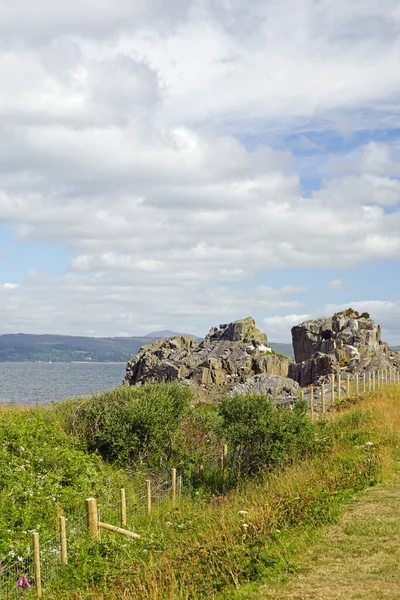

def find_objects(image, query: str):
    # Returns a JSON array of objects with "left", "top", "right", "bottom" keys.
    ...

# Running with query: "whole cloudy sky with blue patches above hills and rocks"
[{"left": 0, "top": 0, "right": 400, "bottom": 344}]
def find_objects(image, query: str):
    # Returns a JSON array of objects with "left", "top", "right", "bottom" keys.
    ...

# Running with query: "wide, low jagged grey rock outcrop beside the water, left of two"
[{"left": 125, "top": 317, "right": 291, "bottom": 398}]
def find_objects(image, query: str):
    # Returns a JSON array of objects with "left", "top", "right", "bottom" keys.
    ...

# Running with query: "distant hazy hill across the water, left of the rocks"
[{"left": 0, "top": 333, "right": 151, "bottom": 362}]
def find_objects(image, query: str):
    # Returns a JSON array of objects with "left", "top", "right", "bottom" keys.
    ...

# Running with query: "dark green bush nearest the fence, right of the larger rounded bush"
[{"left": 219, "top": 394, "right": 317, "bottom": 480}]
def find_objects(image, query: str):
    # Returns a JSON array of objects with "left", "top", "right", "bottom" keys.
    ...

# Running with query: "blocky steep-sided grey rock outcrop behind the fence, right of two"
[{"left": 289, "top": 308, "right": 400, "bottom": 386}]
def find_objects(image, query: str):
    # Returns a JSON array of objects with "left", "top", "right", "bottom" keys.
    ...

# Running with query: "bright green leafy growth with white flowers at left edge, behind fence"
[{"left": 0, "top": 408, "right": 118, "bottom": 561}]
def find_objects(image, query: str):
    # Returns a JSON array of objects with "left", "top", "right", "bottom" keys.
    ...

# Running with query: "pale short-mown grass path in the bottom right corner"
[{"left": 255, "top": 474, "right": 400, "bottom": 600}]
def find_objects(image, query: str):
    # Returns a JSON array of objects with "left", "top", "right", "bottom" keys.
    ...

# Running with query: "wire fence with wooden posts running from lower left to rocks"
[{"left": 0, "top": 369, "right": 400, "bottom": 600}]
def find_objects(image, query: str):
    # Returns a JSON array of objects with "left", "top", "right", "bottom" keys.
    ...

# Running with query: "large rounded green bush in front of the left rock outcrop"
[{"left": 60, "top": 383, "right": 193, "bottom": 469}]
